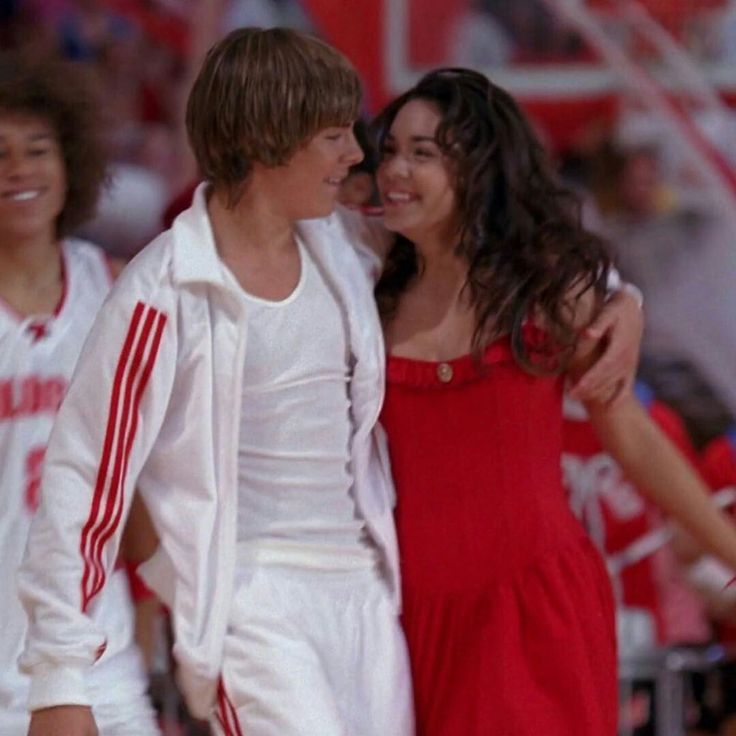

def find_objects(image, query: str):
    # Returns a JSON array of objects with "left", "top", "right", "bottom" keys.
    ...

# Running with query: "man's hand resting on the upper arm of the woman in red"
[{"left": 570, "top": 290, "right": 644, "bottom": 404}]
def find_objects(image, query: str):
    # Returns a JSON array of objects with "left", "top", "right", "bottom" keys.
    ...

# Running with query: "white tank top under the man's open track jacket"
[{"left": 231, "top": 243, "right": 377, "bottom": 570}]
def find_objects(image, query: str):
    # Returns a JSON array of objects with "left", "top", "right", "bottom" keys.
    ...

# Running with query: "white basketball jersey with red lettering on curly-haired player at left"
[{"left": 0, "top": 239, "right": 141, "bottom": 714}]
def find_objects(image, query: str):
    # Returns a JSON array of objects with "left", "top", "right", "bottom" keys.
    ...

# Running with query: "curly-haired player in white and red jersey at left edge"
[{"left": 0, "top": 53, "right": 159, "bottom": 736}]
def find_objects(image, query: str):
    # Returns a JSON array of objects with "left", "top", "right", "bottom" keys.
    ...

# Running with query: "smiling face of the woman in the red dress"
[{"left": 376, "top": 99, "right": 458, "bottom": 249}]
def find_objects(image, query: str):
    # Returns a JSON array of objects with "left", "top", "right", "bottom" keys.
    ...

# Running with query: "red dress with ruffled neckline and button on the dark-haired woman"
[{"left": 382, "top": 340, "right": 618, "bottom": 736}]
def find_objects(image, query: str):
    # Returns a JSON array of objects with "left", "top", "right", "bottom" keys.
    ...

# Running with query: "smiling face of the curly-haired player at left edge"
[{"left": 0, "top": 114, "right": 67, "bottom": 241}]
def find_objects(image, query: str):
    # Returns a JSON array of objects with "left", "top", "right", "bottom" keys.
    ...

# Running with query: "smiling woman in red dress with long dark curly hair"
[{"left": 376, "top": 69, "right": 736, "bottom": 736}]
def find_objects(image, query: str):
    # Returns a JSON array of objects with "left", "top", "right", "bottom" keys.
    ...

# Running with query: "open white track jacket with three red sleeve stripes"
[{"left": 19, "top": 185, "right": 399, "bottom": 717}]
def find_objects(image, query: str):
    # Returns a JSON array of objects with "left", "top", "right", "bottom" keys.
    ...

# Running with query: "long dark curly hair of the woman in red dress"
[{"left": 372, "top": 69, "right": 610, "bottom": 373}]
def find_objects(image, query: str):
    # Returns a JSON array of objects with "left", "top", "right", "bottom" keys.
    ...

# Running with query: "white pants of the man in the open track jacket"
[{"left": 213, "top": 566, "right": 414, "bottom": 736}]
